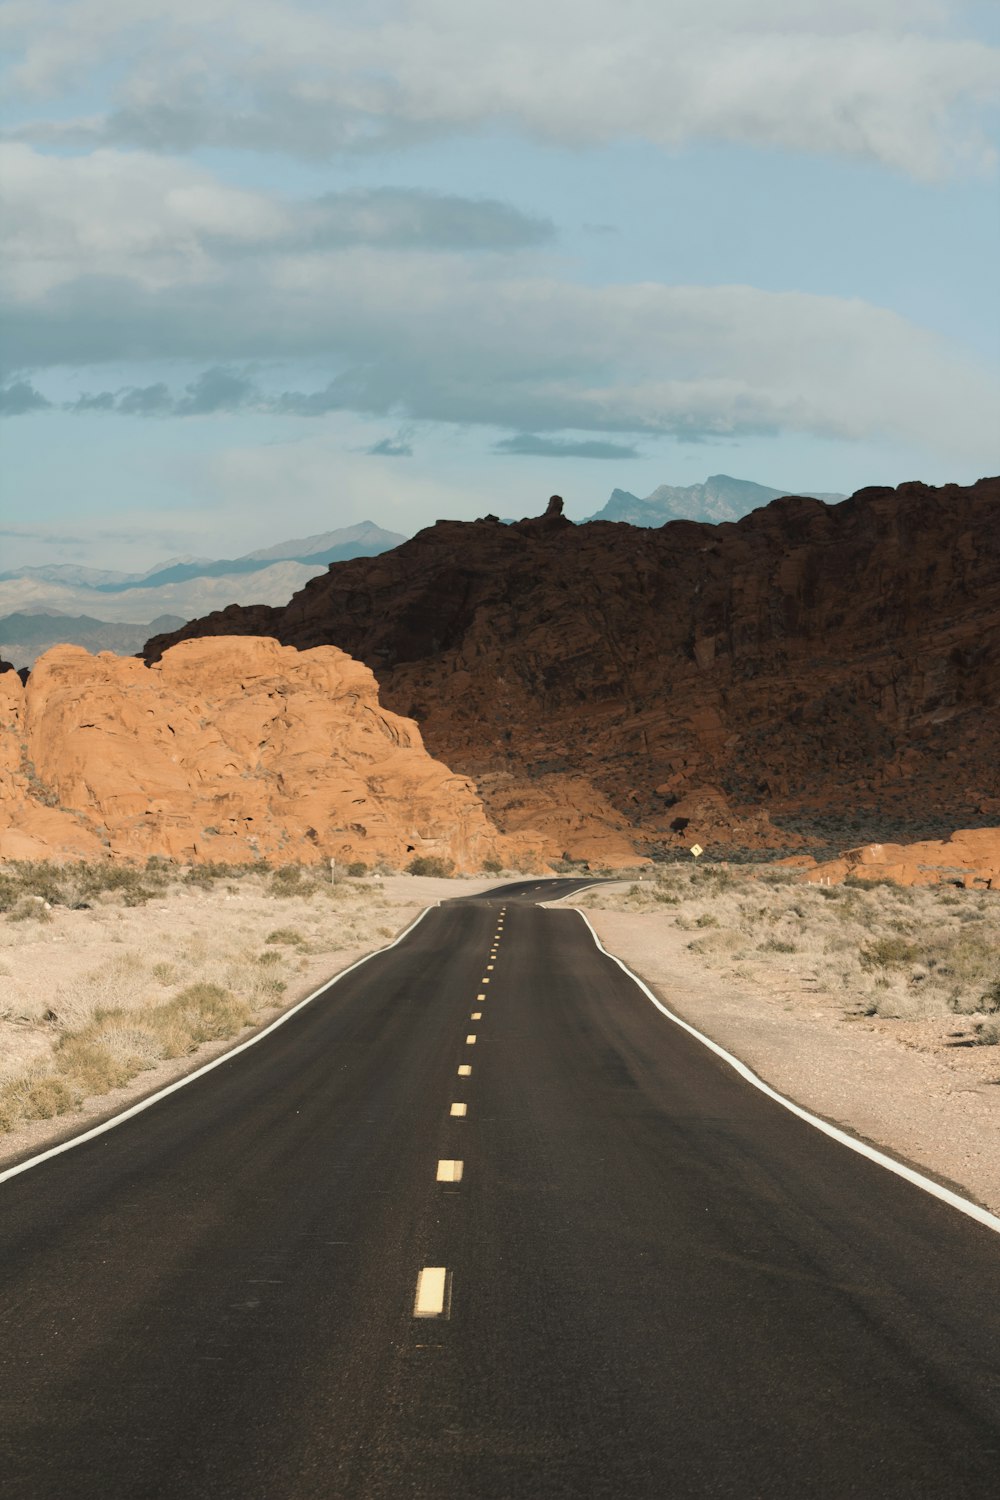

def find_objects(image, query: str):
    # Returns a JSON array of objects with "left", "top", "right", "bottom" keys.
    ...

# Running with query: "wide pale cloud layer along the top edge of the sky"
[{"left": 7, "top": 0, "right": 1000, "bottom": 177}]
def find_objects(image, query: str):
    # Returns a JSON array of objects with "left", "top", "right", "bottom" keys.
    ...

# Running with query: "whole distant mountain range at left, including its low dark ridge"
[{"left": 0, "top": 521, "right": 406, "bottom": 651}]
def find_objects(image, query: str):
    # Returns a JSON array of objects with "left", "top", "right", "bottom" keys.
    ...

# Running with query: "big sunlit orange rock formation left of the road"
[{"left": 0, "top": 638, "right": 539, "bottom": 869}]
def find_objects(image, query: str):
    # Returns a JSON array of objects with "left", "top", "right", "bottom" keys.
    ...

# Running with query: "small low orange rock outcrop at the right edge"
[{"left": 802, "top": 828, "right": 1000, "bottom": 891}]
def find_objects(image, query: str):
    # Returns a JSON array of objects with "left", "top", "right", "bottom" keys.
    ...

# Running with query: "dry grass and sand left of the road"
[{"left": 0, "top": 863, "right": 458, "bottom": 1131}]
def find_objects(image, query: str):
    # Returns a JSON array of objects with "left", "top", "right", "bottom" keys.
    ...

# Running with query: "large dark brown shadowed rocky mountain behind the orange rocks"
[{"left": 145, "top": 479, "right": 1000, "bottom": 843}]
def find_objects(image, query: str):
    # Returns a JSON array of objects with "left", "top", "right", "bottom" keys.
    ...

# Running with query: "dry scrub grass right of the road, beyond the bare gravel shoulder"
[{"left": 577, "top": 864, "right": 1000, "bottom": 1046}]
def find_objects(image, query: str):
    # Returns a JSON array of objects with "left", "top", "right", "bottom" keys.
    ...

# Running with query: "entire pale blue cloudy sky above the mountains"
[{"left": 0, "top": 0, "right": 1000, "bottom": 570}]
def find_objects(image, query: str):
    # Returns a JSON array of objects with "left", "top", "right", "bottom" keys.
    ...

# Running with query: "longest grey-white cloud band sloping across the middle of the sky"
[{"left": 0, "top": 146, "right": 1000, "bottom": 464}]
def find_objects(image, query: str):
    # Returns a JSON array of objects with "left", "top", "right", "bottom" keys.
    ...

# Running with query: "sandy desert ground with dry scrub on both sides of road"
[{"left": 0, "top": 863, "right": 1000, "bottom": 1211}]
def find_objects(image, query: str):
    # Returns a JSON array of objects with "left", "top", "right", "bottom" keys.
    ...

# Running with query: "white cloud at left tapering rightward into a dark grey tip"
[{"left": 0, "top": 143, "right": 555, "bottom": 297}]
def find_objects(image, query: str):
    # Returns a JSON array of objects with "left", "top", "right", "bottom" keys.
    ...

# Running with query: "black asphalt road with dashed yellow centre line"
[{"left": 0, "top": 882, "right": 1000, "bottom": 1500}]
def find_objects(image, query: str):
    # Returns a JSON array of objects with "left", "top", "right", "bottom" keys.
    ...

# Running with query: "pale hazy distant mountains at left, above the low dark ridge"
[{"left": 0, "top": 521, "right": 405, "bottom": 635}]
